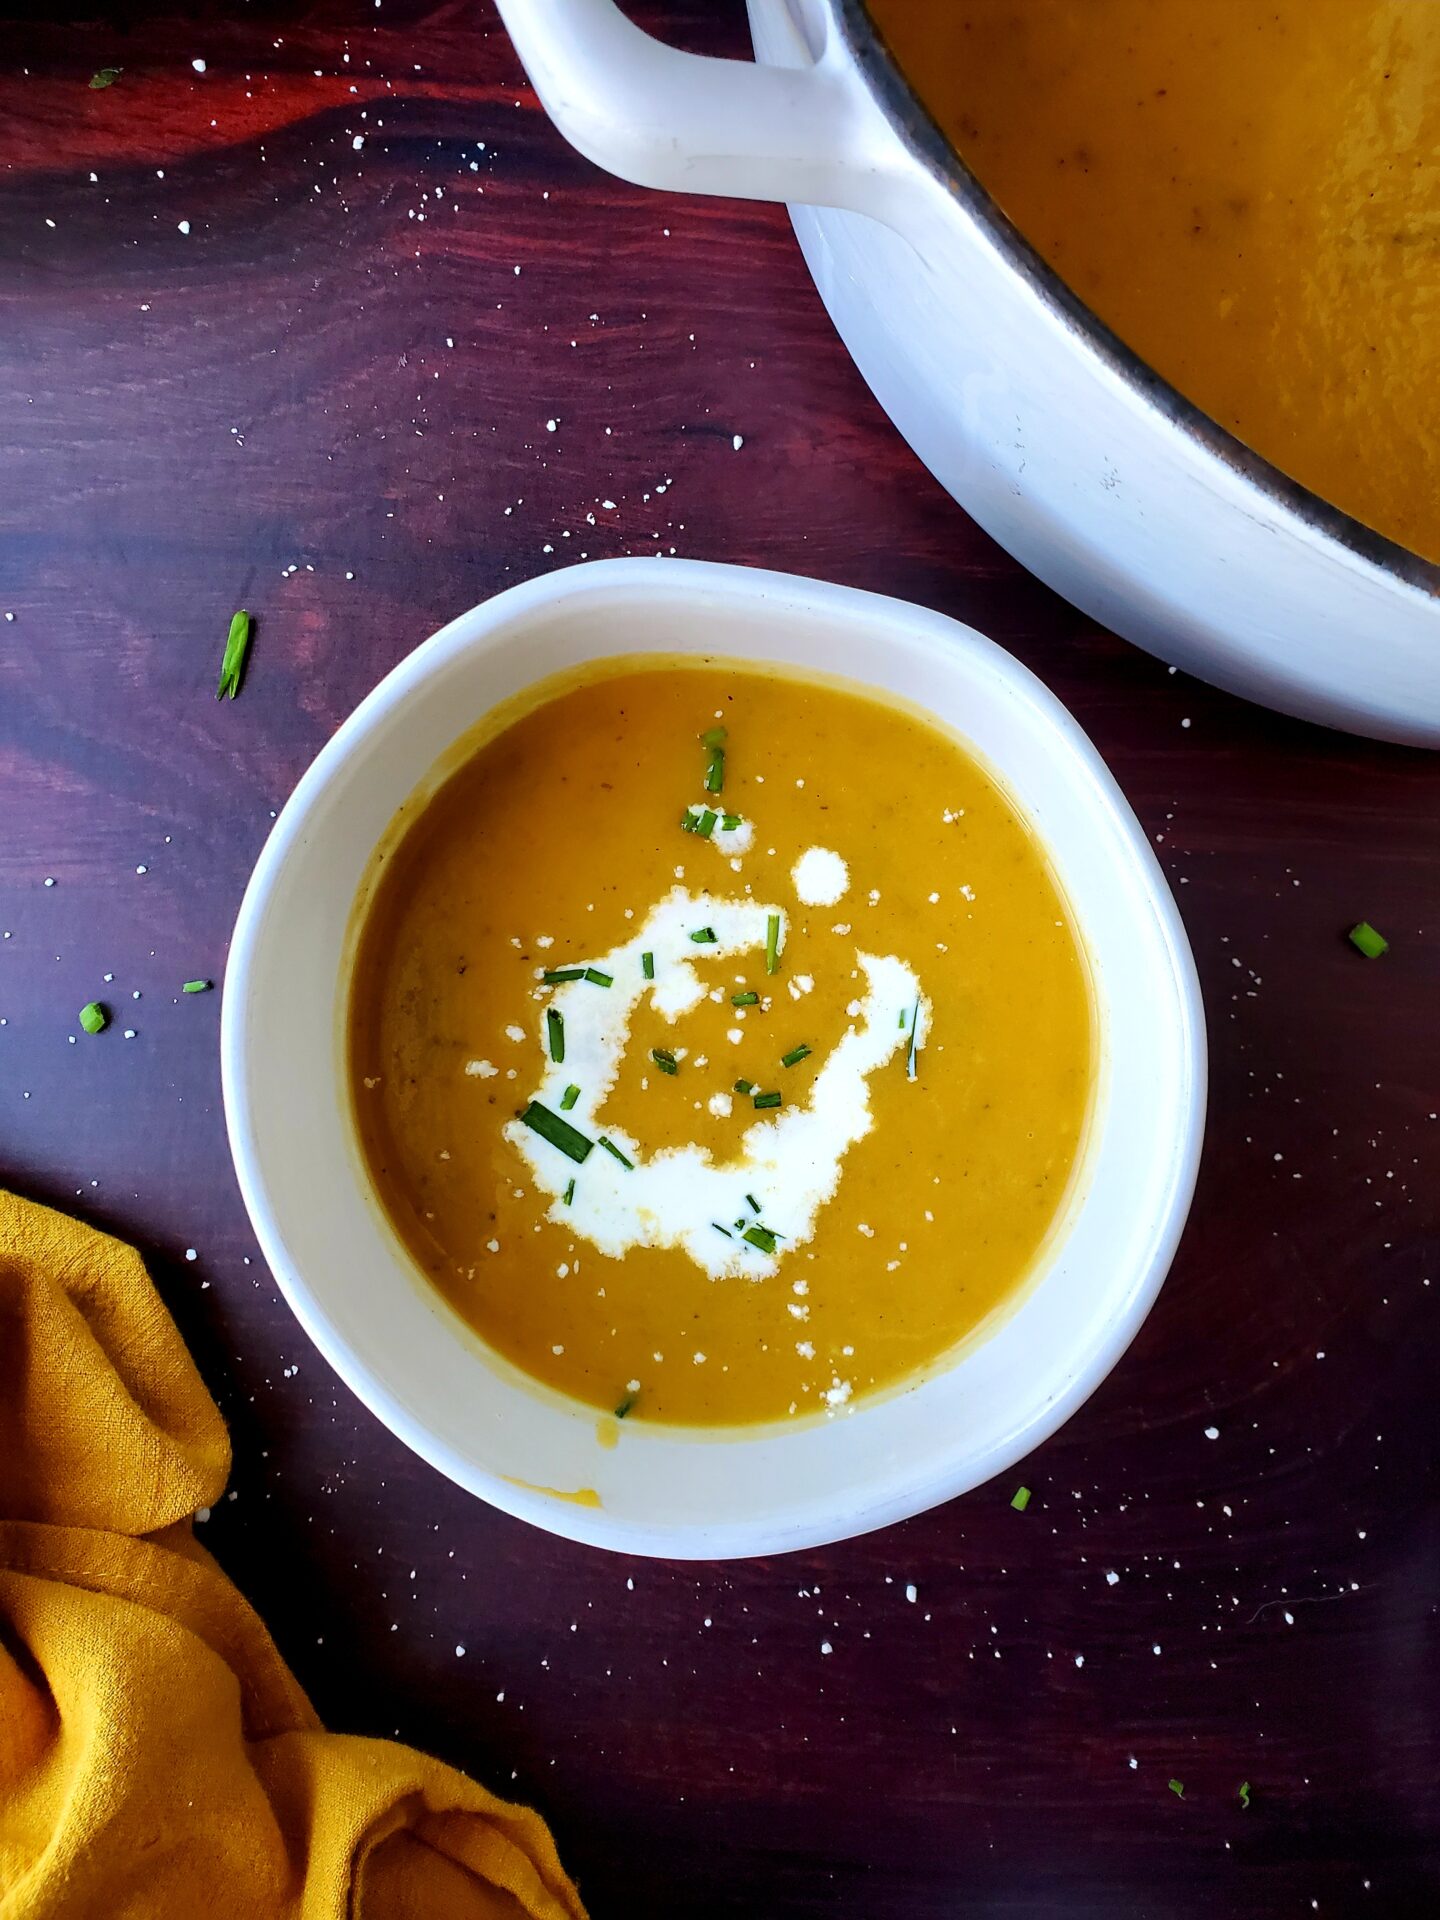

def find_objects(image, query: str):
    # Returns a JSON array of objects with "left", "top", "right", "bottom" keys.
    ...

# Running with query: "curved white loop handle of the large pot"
[{"left": 497, "top": 0, "right": 895, "bottom": 219}]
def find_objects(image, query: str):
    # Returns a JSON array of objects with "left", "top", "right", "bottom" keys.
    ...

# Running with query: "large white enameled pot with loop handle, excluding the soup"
[{"left": 499, "top": 0, "right": 1440, "bottom": 745}]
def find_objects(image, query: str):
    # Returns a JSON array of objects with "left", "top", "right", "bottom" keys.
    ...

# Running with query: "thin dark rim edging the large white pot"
[{"left": 833, "top": 0, "right": 1440, "bottom": 595}]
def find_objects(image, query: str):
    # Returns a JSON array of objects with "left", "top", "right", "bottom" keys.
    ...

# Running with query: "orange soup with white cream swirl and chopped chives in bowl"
[{"left": 348, "top": 659, "right": 1094, "bottom": 1425}]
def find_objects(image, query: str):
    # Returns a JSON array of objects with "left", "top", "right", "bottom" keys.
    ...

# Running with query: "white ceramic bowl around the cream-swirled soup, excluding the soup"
[{"left": 221, "top": 561, "right": 1206, "bottom": 1559}]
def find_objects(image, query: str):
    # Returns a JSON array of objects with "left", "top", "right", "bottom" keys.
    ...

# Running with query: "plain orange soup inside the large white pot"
[{"left": 868, "top": 0, "right": 1440, "bottom": 561}]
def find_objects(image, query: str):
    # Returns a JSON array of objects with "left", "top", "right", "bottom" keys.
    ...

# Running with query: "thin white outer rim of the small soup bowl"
[{"left": 221, "top": 557, "right": 1208, "bottom": 1561}]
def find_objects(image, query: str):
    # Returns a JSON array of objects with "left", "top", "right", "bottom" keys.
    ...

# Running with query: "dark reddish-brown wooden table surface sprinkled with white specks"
[{"left": 0, "top": 0, "right": 1440, "bottom": 1920}]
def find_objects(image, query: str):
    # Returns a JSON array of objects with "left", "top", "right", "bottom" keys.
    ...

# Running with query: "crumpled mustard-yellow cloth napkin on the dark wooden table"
[{"left": 0, "top": 1192, "right": 584, "bottom": 1920}]
